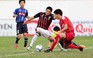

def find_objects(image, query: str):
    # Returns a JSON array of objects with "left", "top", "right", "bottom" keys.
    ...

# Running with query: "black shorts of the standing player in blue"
[{"left": 16, "top": 22, "right": 28, "bottom": 35}]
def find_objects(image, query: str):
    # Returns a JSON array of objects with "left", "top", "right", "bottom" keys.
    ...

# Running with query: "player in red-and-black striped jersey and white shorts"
[{"left": 26, "top": 6, "right": 54, "bottom": 50}]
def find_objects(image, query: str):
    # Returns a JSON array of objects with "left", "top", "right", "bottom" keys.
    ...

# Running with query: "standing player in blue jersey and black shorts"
[{"left": 13, "top": 0, "right": 30, "bottom": 48}]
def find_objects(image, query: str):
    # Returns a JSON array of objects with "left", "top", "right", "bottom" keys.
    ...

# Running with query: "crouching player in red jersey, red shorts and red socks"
[{"left": 45, "top": 9, "right": 83, "bottom": 52}]
